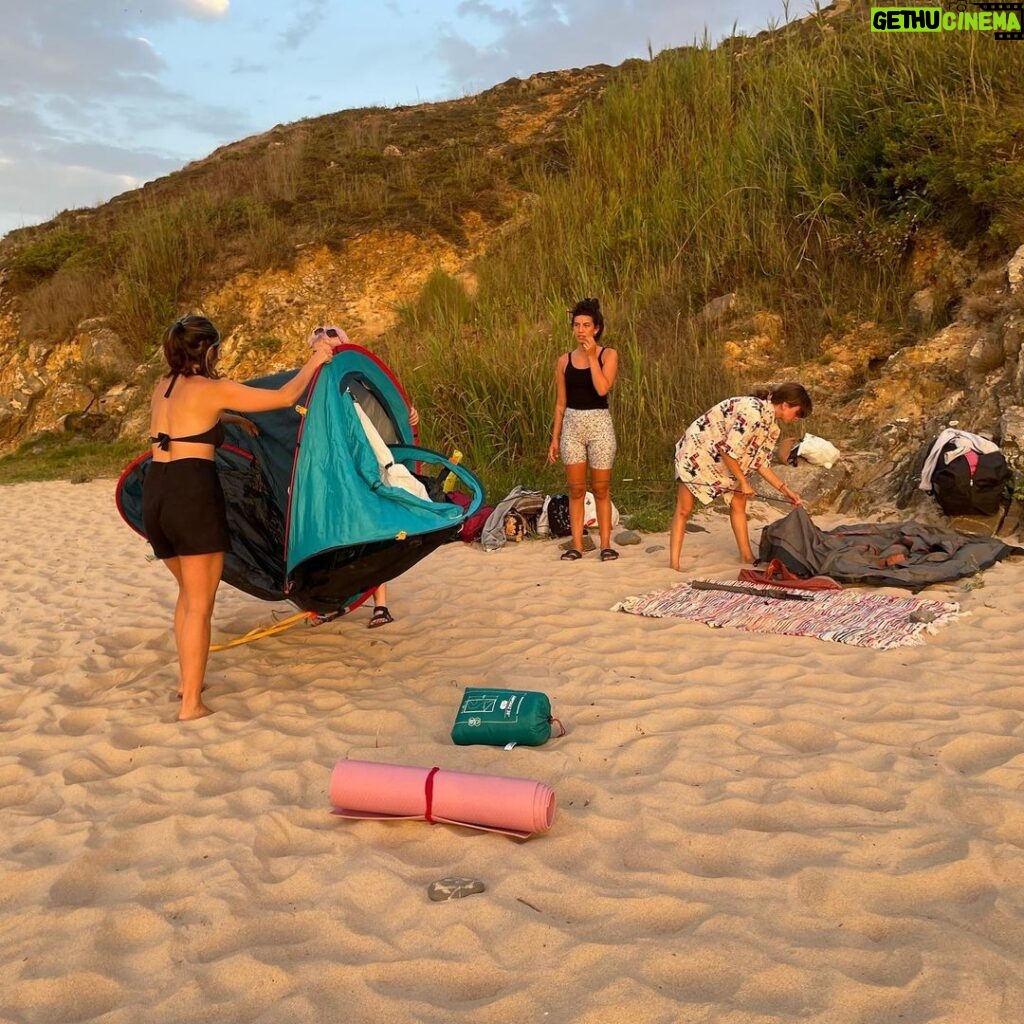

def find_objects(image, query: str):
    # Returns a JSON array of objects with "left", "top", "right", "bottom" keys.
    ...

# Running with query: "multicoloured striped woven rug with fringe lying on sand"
[{"left": 611, "top": 581, "right": 959, "bottom": 650}]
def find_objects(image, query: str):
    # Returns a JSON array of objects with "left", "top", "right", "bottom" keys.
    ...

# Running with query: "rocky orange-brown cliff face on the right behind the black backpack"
[{"left": 722, "top": 239, "right": 1024, "bottom": 535}]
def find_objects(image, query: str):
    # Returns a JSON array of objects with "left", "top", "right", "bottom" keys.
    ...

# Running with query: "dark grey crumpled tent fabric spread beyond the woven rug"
[{"left": 758, "top": 508, "right": 1024, "bottom": 591}]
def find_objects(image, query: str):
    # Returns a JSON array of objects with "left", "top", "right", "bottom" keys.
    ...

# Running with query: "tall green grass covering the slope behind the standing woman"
[{"left": 391, "top": 8, "right": 1024, "bottom": 503}]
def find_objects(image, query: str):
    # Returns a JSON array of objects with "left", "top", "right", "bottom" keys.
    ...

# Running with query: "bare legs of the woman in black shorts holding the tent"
[{"left": 171, "top": 552, "right": 224, "bottom": 722}]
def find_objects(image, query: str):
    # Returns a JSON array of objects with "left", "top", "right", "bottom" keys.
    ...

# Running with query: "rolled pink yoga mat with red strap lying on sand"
[{"left": 331, "top": 761, "right": 555, "bottom": 839}]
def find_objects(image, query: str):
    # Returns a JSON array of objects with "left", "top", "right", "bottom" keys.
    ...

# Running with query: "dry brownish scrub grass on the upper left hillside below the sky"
[{"left": 3, "top": 70, "right": 614, "bottom": 348}]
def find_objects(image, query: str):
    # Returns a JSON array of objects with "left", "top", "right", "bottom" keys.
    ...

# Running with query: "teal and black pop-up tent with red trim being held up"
[{"left": 117, "top": 345, "right": 483, "bottom": 614}]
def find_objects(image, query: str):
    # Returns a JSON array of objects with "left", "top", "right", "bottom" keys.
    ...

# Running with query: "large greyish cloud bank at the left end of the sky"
[{"left": 0, "top": 0, "right": 245, "bottom": 231}]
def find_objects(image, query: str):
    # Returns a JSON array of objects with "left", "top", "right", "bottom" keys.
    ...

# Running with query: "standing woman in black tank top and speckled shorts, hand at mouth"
[{"left": 548, "top": 299, "right": 618, "bottom": 562}]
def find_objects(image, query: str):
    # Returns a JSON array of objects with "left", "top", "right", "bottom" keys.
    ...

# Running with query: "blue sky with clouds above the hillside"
[{"left": 0, "top": 0, "right": 810, "bottom": 236}]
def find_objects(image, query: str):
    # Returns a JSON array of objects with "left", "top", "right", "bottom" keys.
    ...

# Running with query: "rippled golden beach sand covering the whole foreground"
[{"left": 0, "top": 480, "right": 1024, "bottom": 1024}]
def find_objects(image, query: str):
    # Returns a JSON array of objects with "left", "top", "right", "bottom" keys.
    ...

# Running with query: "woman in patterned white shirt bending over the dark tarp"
[{"left": 669, "top": 382, "right": 812, "bottom": 569}]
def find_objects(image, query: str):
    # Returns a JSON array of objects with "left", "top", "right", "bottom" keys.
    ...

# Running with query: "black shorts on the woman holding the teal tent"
[{"left": 142, "top": 459, "right": 231, "bottom": 559}]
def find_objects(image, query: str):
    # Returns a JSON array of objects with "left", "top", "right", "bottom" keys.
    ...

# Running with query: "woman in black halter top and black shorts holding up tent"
[{"left": 142, "top": 314, "right": 332, "bottom": 721}]
